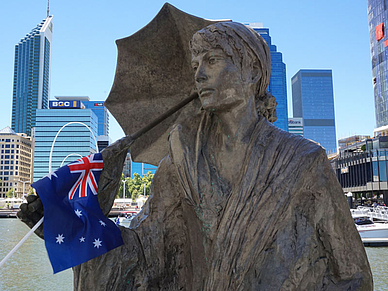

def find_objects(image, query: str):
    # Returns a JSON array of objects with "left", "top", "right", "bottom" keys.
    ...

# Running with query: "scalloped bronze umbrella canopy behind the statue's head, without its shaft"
[{"left": 105, "top": 3, "right": 220, "bottom": 165}]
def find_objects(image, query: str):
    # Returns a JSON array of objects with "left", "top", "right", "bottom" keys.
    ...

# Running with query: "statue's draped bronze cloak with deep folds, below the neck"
[{"left": 74, "top": 112, "right": 372, "bottom": 290}]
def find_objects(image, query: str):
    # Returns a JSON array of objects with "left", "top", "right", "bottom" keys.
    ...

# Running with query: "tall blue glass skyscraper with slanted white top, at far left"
[{"left": 12, "top": 16, "right": 53, "bottom": 136}]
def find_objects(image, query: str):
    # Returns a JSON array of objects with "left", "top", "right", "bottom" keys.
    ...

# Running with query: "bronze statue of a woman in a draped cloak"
[{"left": 21, "top": 6, "right": 373, "bottom": 290}]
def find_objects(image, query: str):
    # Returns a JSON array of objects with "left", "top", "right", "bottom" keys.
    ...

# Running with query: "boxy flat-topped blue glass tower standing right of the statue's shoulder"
[{"left": 291, "top": 70, "right": 337, "bottom": 155}]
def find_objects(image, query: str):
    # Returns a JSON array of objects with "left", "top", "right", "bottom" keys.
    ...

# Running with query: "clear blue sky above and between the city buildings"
[{"left": 0, "top": 0, "right": 375, "bottom": 141}]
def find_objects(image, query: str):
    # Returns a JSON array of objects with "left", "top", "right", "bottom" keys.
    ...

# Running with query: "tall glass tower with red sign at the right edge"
[{"left": 368, "top": 0, "right": 388, "bottom": 128}]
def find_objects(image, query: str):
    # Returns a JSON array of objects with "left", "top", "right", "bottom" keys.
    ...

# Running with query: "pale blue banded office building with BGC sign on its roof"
[{"left": 34, "top": 97, "right": 98, "bottom": 181}]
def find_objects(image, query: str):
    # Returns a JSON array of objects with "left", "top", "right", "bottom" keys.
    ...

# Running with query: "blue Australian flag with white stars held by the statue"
[{"left": 31, "top": 153, "right": 123, "bottom": 274}]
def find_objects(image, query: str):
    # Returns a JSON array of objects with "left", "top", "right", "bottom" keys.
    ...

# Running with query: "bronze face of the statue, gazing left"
[{"left": 191, "top": 49, "right": 247, "bottom": 111}]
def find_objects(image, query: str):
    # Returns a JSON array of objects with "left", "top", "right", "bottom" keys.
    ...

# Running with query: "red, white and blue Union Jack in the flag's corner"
[{"left": 68, "top": 155, "right": 103, "bottom": 200}]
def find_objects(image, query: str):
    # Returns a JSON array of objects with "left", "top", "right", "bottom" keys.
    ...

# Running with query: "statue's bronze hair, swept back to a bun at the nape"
[{"left": 190, "top": 22, "right": 277, "bottom": 122}]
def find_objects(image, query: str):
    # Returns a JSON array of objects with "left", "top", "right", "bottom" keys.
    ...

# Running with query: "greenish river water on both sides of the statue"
[{"left": 0, "top": 218, "right": 388, "bottom": 291}]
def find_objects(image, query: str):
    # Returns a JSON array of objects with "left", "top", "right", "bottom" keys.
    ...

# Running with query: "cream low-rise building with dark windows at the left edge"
[{"left": 0, "top": 126, "right": 33, "bottom": 198}]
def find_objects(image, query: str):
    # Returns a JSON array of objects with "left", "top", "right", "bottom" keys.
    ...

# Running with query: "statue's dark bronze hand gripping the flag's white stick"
[{"left": 17, "top": 195, "right": 44, "bottom": 239}]
